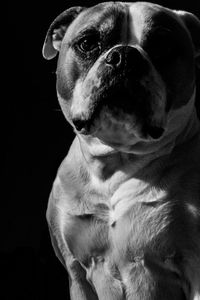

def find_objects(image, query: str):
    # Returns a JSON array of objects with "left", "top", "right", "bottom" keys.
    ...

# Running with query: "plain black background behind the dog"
[{"left": 3, "top": 0, "right": 200, "bottom": 300}]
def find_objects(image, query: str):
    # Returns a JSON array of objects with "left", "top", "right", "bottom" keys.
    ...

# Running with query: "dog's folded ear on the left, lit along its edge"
[{"left": 42, "top": 6, "right": 85, "bottom": 59}]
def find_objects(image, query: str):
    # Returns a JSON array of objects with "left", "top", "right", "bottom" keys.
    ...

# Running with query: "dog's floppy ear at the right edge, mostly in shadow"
[{"left": 175, "top": 10, "right": 200, "bottom": 64}]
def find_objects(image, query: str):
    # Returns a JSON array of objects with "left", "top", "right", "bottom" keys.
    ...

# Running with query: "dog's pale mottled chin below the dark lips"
[{"left": 77, "top": 107, "right": 164, "bottom": 152}]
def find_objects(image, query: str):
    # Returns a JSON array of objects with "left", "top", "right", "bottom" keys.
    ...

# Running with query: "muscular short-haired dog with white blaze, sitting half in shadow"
[{"left": 43, "top": 2, "right": 200, "bottom": 300}]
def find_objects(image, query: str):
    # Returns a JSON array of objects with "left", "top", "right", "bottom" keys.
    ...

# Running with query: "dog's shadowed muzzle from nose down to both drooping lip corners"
[{"left": 72, "top": 45, "right": 163, "bottom": 139}]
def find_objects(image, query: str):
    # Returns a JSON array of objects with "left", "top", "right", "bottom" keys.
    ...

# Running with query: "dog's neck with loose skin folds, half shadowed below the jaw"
[{"left": 78, "top": 95, "right": 200, "bottom": 190}]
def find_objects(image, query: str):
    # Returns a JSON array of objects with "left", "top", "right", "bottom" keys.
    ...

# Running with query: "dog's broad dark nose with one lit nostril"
[{"left": 105, "top": 45, "right": 148, "bottom": 73}]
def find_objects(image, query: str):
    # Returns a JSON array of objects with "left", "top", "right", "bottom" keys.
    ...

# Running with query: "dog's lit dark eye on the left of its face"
[{"left": 77, "top": 34, "right": 100, "bottom": 53}]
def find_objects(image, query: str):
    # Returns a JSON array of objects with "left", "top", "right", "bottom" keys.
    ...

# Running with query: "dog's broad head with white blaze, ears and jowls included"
[{"left": 43, "top": 2, "right": 200, "bottom": 151}]
